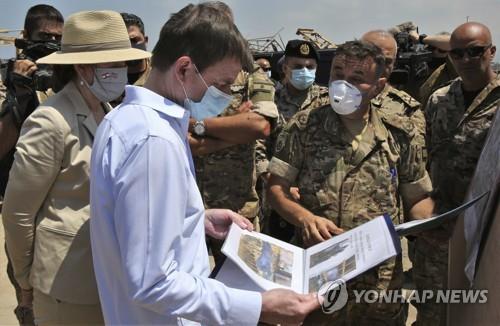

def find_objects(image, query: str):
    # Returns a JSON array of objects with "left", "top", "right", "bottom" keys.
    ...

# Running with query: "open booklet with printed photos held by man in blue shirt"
[{"left": 216, "top": 215, "right": 401, "bottom": 293}]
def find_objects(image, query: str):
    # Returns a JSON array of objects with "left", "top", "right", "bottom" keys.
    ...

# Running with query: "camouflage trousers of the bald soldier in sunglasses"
[{"left": 413, "top": 237, "right": 448, "bottom": 326}]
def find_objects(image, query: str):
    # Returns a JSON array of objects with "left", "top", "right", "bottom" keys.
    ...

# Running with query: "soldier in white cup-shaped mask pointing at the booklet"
[{"left": 269, "top": 41, "right": 432, "bottom": 325}]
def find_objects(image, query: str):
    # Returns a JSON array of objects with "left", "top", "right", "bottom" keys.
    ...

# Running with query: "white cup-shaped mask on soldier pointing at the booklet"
[{"left": 328, "top": 80, "right": 363, "bottom": 115}]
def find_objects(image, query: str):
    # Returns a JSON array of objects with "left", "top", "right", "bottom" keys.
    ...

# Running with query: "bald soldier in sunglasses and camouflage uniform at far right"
[{"left": 414, "top": 23, "right": 500, "bottom": 326}]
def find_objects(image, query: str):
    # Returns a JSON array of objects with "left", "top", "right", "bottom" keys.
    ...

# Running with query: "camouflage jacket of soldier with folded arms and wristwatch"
[{"left": 194, "top": 70, "right": 278, "bottom": 219}]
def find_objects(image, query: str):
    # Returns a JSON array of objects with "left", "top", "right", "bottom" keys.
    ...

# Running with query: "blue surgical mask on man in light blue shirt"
[{"left": 182, "top": 66, "right": 233, "bottom": 121}]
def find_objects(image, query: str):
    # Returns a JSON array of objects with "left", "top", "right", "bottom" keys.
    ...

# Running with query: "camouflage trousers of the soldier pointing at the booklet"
[{"left": 304, "top": 255, "right": 408, "bottom": 326}]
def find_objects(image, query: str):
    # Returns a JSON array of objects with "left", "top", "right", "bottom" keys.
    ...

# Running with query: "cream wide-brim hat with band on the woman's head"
[{"left": 36, "top": 10, "right": 151, "bottom": 65}]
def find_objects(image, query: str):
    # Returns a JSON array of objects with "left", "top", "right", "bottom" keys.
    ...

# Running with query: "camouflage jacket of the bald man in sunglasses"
[{"left": 425, "top": 76, "right": 500, "bottom": 212}]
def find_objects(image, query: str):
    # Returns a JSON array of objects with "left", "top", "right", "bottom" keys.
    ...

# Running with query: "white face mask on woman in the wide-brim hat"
[{"left": 82, "top": 67, "right": 128, "bottom": 102}]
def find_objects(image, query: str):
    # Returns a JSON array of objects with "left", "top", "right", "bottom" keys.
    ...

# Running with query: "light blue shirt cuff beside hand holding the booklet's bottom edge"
[{"left": 225, "top": 288, "right": 262, "bottom": 325}]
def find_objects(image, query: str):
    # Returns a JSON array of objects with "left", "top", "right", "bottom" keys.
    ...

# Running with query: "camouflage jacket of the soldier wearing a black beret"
[{"left": 256, "top": 84, "right": 330, "bottom": 175}]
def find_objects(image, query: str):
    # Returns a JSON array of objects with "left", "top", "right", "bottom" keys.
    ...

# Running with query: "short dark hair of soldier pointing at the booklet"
[{"left": 335, "top": 40, "right": 385, "bottom": 78}]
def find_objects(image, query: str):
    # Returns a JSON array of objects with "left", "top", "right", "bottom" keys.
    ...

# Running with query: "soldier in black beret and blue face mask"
[{"left": 256, "top": 40, "right": 330, "bottom": 241}]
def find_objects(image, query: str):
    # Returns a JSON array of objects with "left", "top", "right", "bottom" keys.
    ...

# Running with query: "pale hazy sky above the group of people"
[{"left": 0, "top": 0, "right": 500, "bottom": 62}]
